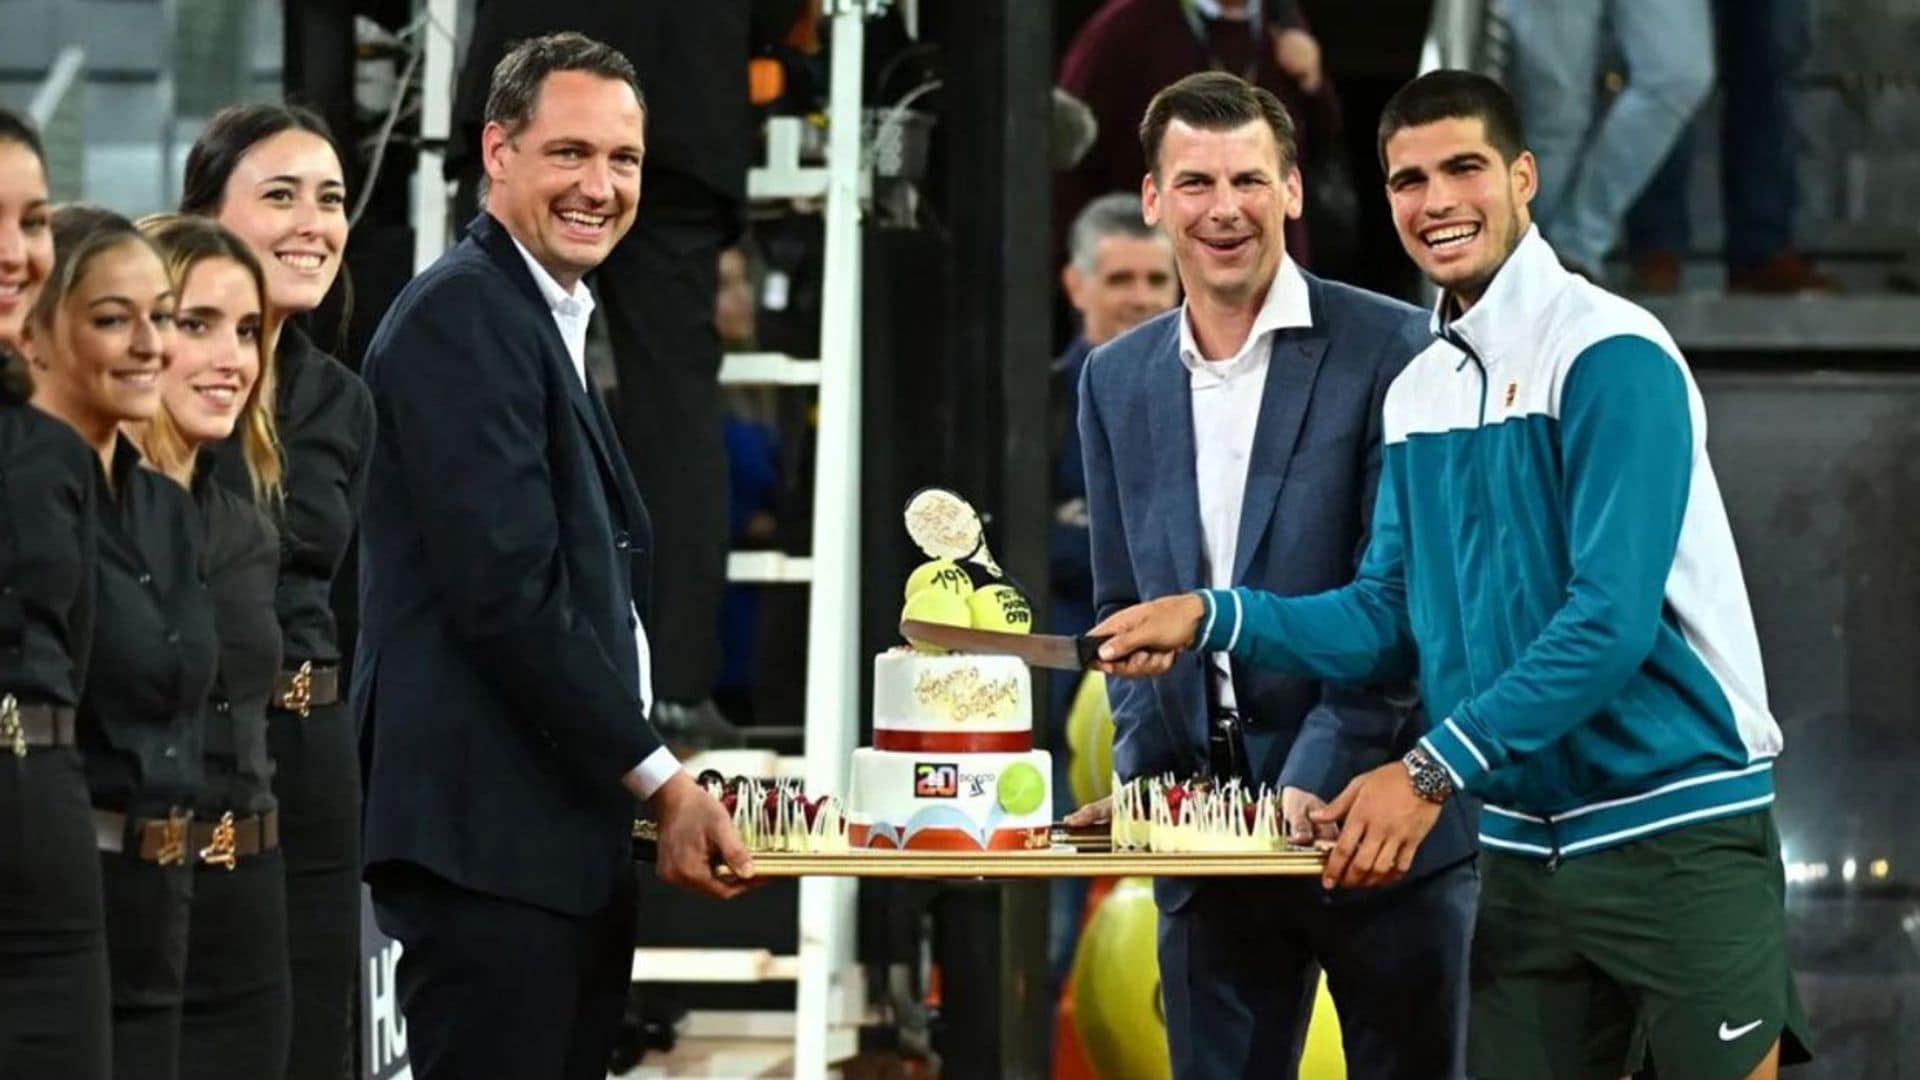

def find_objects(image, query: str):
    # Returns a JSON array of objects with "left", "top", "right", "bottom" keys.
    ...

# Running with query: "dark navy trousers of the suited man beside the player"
[{"left": 1160, "top": 861, "right": 1480, "bottom": 1080}]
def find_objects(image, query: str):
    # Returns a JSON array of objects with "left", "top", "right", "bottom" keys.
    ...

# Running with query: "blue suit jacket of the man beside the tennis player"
[{"left": 1079, "top": 265, "right": 1476, "bottom": 909}]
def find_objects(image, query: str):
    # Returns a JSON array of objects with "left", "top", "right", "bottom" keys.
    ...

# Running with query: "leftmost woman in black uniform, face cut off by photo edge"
[{"left": 0, "top": 110, "right": 109, "bottom": 1080}]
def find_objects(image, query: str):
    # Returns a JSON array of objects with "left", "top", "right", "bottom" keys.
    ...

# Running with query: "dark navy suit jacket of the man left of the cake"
[{"left": 351, "top": 215, "right": 660, "bottom": 915}]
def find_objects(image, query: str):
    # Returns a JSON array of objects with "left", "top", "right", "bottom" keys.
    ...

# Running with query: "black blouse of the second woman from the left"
[{"left": 79, "top": 436, "right": 219, "bottom": 815}]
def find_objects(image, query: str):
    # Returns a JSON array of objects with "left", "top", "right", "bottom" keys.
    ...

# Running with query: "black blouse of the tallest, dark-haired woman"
[{"left": 215, "top": 323, "right": 374, "bottom": 667}]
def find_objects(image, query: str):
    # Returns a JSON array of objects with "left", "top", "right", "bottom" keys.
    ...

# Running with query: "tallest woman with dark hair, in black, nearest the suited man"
[{"left": 180, "top": 104, "right": 374, "bottom": 1080}]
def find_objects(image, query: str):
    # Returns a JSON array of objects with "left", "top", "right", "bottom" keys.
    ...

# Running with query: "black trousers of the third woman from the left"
[{"left": 180, "top": 849, "right": 292, "bottom": 1080}]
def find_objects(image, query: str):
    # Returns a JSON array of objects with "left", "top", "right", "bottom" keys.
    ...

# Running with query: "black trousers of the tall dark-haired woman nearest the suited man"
[{"left": 267, "top": 701, "right": 361, "bottom": 1080}]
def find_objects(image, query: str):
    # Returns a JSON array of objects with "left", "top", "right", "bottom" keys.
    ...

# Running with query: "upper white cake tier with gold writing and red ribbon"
[{"left": 874, "top": 650, "right": 1033, "bottom": 753}]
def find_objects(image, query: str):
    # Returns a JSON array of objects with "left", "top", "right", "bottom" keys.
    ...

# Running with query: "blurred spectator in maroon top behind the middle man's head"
[{"left": 1054, "top": 0, "right": 1338, "bottom": 263}]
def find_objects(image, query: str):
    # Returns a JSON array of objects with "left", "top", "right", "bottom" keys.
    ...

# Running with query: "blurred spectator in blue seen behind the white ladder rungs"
[{"left": 714, "top": 248, "right": 780, "bottom": 724}]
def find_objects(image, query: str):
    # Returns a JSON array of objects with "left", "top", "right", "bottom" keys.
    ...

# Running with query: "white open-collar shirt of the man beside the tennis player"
[{"left": 1181, "top": 256, "right": 1313, "bottom": 709}]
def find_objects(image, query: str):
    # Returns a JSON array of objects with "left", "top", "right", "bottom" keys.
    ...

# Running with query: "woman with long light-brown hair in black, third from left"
[{"left": 138, "top": 215, "right": 292, "bottom": 1080}]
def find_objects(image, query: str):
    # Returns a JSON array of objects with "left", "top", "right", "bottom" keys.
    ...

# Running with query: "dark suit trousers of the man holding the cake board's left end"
[{"left": 369, "top": 863, "right": 636, "bottom": 1080}]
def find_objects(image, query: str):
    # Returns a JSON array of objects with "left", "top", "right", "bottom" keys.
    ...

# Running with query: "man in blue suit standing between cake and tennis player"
[{"left": 1077, "top": 73, "right": 1476, "bottom": 1080}]
